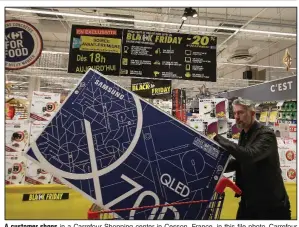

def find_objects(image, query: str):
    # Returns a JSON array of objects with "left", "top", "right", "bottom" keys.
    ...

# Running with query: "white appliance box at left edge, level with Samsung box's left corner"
[{"left": 5, "top": 120, "right": 30, "bottom": 155}]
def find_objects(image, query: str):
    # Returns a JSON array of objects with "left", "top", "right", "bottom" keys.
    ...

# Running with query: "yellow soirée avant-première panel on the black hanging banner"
[{"left": 80, "top": 36, "right": 121, "bottom": 54}]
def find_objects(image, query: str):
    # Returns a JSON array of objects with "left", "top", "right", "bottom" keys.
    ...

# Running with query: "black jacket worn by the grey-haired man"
[{"left": 214, "top": 121, "right": 288, "bottom": 208}]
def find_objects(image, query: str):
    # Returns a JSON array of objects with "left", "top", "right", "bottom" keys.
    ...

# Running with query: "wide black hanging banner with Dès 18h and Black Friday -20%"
[{"left": 68, "top": 25, "right": 217, "bottom": 82}]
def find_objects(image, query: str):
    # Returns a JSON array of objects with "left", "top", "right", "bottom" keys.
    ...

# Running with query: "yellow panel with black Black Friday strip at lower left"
[{"left": 5, "top": 184, "right": 92, "bottom": 220}]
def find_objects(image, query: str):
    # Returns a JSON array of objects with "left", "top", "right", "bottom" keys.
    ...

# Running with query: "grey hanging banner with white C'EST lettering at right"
[{"left": 219, "top": 76, "right": 297, "bottom": 102}]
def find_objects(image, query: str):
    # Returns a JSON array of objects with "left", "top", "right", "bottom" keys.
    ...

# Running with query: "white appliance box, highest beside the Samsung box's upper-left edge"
[{"left": 30, "top": 91, "right": 60, "bottom": 121}]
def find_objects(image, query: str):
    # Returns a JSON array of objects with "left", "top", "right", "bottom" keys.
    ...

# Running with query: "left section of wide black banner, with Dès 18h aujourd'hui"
[{"left": 68, "top": 25, "right": 123, "bottom": 76}]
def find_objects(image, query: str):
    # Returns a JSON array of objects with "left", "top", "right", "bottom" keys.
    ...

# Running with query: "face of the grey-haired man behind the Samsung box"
[{"left": 233, "top": 105, "right": 254, "bottom": 129}]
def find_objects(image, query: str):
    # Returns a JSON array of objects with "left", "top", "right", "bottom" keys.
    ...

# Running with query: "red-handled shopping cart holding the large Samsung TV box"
[{"left": 88, "top": 178, "right": 242, "bottom": 220}]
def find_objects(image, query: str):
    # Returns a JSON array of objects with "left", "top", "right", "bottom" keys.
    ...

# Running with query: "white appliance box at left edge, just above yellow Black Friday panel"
[{"left": 5, "top": 154, "right": 27, "bottom": 185}]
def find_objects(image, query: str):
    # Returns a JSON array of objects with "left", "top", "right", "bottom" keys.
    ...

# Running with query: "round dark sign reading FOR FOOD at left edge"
[{"left": 5, "top": 20, "right": 43, "bottom": 70}]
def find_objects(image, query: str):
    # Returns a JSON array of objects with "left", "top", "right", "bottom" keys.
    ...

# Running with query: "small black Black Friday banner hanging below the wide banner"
[{"left": 131, "top": 79, "right": 171, "bottom": 99}]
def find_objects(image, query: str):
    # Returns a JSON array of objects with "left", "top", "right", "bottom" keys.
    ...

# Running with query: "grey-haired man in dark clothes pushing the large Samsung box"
[{"left": 214, "top": 98, "right": 291, "bottom": 220}]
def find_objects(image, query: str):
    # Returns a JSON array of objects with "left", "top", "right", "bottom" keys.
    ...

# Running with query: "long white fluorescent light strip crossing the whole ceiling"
[{"left": 5, "top": 8, "right": 297, "bottom": 37}]
